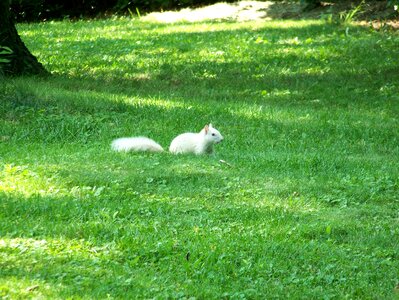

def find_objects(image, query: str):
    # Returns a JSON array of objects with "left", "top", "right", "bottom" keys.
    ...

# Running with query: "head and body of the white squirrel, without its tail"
[{"left": 169, "top": 124, "right": 223, "bottom": 155}]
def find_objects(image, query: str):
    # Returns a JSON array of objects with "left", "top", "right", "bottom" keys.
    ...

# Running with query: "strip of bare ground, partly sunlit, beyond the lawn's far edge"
[{"left": 144, "top": 0, "right": 399, "bottom": 28}]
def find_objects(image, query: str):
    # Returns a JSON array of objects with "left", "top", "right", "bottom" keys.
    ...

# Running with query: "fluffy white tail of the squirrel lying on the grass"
[{"left": 111, "top": 136, "right": 163, "bottom": 152}]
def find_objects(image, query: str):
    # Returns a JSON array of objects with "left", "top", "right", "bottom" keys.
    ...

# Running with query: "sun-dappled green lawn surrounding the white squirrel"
[{"left": 0, "top": 18, "right": 399, "bottom": 299}]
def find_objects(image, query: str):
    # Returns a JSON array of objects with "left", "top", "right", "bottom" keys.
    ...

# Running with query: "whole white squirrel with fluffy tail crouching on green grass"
[{"left": 111, "top": 124, "right": 223, "bottom": 155}]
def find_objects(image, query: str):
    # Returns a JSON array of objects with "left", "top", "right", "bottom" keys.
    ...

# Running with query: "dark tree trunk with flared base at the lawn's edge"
[{"left": 0, "top": 0, "right": 49, "bottom": 76}]
